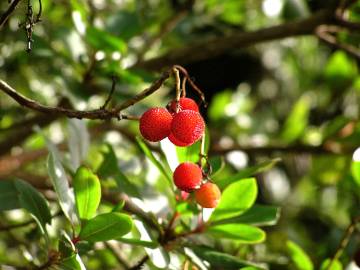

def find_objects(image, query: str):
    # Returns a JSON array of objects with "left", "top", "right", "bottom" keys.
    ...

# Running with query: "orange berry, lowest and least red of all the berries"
[{"left": 195, "top": 182, "right": 221, "bottom": 208}]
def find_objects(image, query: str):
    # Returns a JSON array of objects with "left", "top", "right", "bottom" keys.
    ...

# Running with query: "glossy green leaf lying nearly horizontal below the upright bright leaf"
[{"left": 79, "top": 212, "right": 132, "bottom": 242}]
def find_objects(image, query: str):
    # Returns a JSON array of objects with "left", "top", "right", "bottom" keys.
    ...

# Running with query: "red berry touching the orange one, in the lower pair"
[{"left": 173, "top": 162, "right": 202, "bottom": 192}]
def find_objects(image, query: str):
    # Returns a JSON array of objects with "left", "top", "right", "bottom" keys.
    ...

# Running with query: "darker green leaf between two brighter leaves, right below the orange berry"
[{"left": 214, "top": 204, "right": 280, "bottom": 226}]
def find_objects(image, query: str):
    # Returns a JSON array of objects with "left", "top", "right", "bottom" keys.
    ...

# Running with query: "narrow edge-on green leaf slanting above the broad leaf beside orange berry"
[{"left": 216, "top": 158, "right": 281, "bottom": 188}]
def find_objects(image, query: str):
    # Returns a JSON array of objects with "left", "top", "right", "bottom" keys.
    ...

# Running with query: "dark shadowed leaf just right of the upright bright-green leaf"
[{"left": 97, "top": 144, "right": 140, "bottom": 198}]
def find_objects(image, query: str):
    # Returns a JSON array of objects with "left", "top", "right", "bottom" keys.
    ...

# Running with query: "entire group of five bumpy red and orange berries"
[{"left": 140, "top": 97, "right": 221, "bottom": 208}]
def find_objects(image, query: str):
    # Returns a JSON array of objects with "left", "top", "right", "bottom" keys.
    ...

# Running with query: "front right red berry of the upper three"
[{"left": 171, "top": 110, "right": 205, "bottom": 144}]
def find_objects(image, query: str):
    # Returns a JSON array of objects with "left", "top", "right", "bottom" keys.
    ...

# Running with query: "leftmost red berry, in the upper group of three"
[{"left": 139, "top": 108, "right": 172, "bottom": 142}]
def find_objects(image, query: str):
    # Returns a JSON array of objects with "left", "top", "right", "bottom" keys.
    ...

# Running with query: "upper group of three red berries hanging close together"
[{"left": 140, "top": 98, "right": 205, "bottom": 147}]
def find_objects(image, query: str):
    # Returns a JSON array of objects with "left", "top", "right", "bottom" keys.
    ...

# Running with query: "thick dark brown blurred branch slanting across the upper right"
[{"left": 135, "top": 9, "right": 335, "bottom": 70}]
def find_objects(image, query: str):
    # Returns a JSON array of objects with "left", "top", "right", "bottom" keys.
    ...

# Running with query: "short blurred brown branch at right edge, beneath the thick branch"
[{"left": 316, "top": 25, "right": 360, "bottom": 60}]
